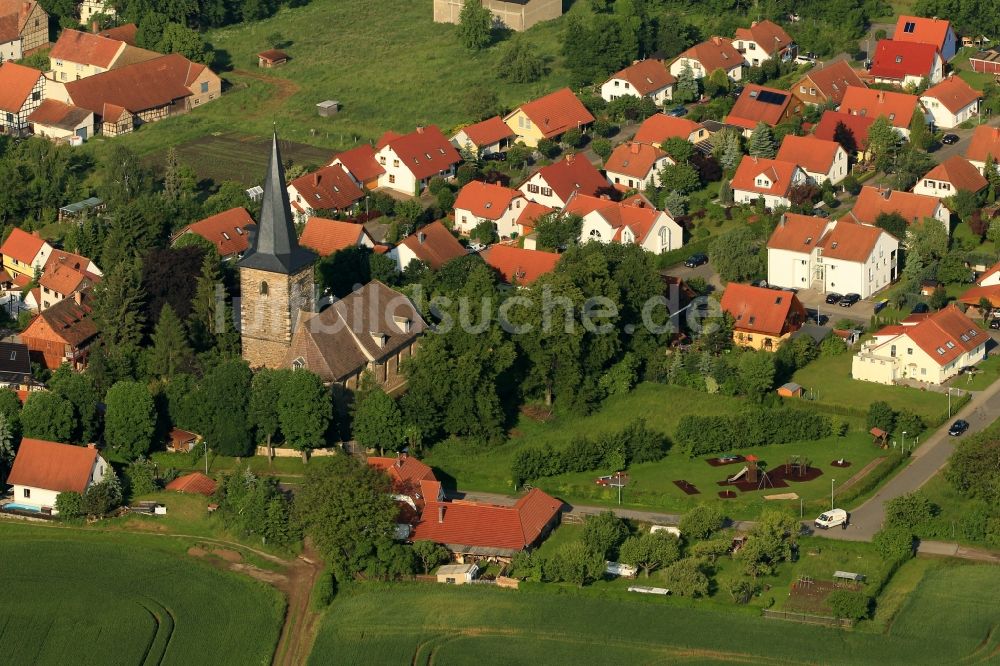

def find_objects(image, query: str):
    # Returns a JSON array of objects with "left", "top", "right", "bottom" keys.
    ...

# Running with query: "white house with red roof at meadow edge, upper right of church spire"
[{"left": 375, "top": 125, "right": 462, "bottom": 195}]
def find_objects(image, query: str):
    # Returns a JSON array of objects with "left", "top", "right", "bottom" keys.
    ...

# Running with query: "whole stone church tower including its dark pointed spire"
[{"left": 237, "top": 134, "right": 316, "bottom": 368}]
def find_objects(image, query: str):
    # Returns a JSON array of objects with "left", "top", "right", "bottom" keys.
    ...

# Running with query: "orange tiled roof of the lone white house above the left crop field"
[{"left": 7, "top": 436, "right": 97, "bottom": 493}]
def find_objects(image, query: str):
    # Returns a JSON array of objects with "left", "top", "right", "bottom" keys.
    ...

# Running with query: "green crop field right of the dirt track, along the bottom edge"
[{"left": 310, "top": 566, "right": 1000, "bottom": 666}]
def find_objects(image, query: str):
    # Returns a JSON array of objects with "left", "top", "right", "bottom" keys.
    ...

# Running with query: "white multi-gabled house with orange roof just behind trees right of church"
[{"left": 563, "top": 194, "right": 684, "bottom": 254}]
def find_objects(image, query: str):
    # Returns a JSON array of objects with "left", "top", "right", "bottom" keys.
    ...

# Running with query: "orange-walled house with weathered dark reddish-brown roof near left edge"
[{"left": 21, "top": 291, "right": 98, "bottom": 370}]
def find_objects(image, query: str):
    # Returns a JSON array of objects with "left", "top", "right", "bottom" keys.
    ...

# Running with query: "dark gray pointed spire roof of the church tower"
[{"left": 238, "top": 134, "right": 316, "bottom": 275}]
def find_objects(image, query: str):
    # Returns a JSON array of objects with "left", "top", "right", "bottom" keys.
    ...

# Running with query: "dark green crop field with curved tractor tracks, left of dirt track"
[{"left": 0, "top": 524, "right": 284, "bottom": 665}]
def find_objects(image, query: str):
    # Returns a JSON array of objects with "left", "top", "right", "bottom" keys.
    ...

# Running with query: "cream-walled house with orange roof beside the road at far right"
[{"left": 851, "top": 305, "right": 990, "bottom": 384}]
